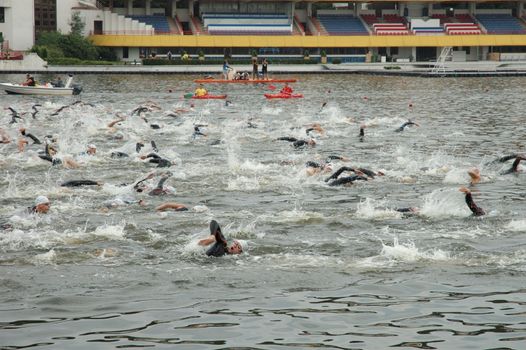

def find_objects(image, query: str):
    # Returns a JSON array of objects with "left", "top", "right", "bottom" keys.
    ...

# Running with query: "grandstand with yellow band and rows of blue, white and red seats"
[{"left": 0, "top": 0, "right": 526, "bottom": 61}]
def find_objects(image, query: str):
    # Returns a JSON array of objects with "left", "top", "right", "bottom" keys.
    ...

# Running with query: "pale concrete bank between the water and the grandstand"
[{"left": 0, "top": 61, "right": 526, "bottom": 77}]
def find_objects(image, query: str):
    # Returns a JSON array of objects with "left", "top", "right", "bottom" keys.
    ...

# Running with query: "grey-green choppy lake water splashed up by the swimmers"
[{"left": 0, "top": 75, "right": 526, "bottom": 350}]
